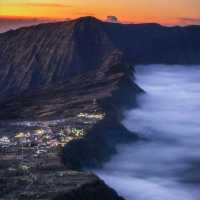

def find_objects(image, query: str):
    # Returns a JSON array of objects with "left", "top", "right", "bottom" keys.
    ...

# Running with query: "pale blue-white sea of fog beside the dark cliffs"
[{"left": 97, "top": 65, "right": 200, "bottom": 200}]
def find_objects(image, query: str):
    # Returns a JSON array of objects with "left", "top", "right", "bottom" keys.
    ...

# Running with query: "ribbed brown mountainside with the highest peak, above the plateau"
[{"left": 0, "top": 18, "right": 116, "bottom": 96}]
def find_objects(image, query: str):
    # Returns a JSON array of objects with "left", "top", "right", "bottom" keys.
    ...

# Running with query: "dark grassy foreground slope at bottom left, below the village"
[{"left": 0, "top": 170, "right": 123, "bottom": 200}]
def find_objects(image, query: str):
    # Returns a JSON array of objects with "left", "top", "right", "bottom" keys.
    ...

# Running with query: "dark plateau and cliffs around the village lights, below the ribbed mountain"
[{"left": 0, "top": 59, "right": 142, "bottom": 200}]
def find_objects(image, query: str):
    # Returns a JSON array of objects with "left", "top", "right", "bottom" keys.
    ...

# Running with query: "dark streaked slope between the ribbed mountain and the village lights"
[{"left": 0, "top": 64, "right": 141, "bottom": 120}]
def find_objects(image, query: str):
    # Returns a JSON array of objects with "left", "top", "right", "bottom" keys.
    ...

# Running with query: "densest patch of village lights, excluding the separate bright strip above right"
[{"left": 0, "top": 127, "right": 85, "bottom": 157}]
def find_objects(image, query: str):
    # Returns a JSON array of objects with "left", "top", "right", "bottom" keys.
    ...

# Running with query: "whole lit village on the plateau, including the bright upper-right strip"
[{"left": 0, "top": 113, "right": 105, "bottom": 171}]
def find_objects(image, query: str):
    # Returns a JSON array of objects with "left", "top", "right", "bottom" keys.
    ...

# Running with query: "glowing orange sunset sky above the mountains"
[{"left": 0, "top": 0, "right": 200, "bottom": 25}]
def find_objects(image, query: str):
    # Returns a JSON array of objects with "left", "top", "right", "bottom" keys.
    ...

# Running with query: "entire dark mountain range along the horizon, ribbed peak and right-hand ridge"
[{"left": 0, "top": 17, "right": 200, "bottom": 94}]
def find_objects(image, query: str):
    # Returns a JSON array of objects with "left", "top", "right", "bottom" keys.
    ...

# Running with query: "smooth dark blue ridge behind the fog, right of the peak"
[{"left": 105, "top": 24, "right": 200, "bottom": 64}]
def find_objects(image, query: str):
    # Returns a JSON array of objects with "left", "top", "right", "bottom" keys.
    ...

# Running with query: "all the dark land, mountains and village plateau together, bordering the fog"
[{"left": 0, "top": 17, "right": 200, "bottom": 200}]
